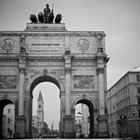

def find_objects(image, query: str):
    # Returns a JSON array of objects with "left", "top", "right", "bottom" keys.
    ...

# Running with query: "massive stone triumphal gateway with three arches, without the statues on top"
[{"left": 0, "top": 23, "right": 109, "bottom": 138}]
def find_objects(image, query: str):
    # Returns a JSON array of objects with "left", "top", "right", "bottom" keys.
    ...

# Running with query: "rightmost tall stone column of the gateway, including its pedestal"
[{"left": 97, "top": 53, "right": 108, "bottom": 137}]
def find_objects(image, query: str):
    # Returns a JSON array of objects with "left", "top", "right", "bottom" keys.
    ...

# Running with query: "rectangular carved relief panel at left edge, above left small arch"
[{"left": 0, "top": 75, "right": 17, "bottom": 89}]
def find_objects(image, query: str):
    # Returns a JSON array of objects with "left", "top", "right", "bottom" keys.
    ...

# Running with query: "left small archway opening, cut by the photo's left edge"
[{"left": 0, "top": 99, "right": 15, "bottom": 138}]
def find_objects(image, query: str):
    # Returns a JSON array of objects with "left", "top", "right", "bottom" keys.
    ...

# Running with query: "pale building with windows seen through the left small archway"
[{"left": 2, "top": 104, "right": 15, "bottom": 138}]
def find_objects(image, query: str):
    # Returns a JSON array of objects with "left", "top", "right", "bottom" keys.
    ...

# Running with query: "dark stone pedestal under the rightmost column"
[{"left": 98, "top": 115, "right": 108, "bottom": 138}]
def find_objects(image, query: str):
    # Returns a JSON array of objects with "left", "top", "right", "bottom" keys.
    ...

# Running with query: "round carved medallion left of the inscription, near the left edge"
[{"left": 1, "top": 38, "right": 14, "bottom": 53}]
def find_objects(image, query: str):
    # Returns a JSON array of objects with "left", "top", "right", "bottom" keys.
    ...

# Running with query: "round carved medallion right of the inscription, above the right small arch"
[{"left": 77, "top": 38, "right": 89, "bottom": 52}]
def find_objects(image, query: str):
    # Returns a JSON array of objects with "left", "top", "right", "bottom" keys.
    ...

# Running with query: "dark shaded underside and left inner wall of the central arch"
[{"left": 29, "top": 75, "right": 61, "bottom": 137}]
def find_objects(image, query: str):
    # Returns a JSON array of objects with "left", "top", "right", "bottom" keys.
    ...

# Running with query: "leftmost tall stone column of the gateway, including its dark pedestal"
[{"left": 15, "top": 56, "right": 25, "bottom": 138}]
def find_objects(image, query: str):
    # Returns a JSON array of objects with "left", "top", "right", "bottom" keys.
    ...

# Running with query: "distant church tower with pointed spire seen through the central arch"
[{"left": 37, "top": 91, "right": 44, "bottom": 122}]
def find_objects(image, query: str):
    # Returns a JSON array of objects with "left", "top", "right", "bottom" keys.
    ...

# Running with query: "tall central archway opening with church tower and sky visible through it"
[{"left": 31, "top": 76, "right": 60, "bottom": 138}]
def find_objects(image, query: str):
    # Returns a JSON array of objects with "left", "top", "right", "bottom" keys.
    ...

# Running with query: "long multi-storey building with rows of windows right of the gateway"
[{"left": 106, "top": 71, "right": 140, "bottom": 137}]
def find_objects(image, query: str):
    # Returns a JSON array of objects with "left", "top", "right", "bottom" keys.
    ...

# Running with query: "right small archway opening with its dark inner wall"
[{"left": 75, "top": 99, "right": 94, "bottom": 138}]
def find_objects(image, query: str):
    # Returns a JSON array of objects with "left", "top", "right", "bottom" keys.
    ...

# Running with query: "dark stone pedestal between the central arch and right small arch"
[{"left": 64, "top": 115, "right": 75, "bottom": 138}]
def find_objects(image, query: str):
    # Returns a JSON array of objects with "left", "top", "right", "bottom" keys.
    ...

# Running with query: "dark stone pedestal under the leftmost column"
[{"left": 15, "top": 116, "right": 25, "bottom": 138}]
